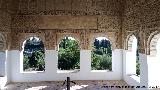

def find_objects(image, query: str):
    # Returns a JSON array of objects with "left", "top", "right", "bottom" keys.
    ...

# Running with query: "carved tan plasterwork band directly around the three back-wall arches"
[{"left": 11, "top": 29, "right": 121, "bottom": 50}]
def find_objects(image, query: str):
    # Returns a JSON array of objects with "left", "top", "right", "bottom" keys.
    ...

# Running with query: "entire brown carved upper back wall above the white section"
[{"left": 11, "top": 0, "right": 122, "bottom": 50}]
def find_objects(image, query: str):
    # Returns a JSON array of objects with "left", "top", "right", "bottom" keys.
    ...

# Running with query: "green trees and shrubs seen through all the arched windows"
[{"left": 23, "top": 37, "right": 140, "bottom": 75}]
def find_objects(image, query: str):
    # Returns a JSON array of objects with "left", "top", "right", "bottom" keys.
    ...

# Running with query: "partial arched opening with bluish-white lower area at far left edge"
[{"left": 0, "top": 33, "right": 6, "bottom": 77}]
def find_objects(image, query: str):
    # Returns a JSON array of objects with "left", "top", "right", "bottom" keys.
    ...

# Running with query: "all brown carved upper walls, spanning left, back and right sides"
[{"left": 0, "top": 0, "right": 160, "bottom": 54}]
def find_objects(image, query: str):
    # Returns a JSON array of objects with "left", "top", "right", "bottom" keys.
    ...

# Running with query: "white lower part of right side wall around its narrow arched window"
[{"left": 123, "top": 50, "right": 148, "bottom": 90}]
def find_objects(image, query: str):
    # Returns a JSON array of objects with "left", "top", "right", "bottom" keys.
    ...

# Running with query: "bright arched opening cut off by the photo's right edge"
[{"left": 148, "top": 32, "right": 160, "bottom": 86}]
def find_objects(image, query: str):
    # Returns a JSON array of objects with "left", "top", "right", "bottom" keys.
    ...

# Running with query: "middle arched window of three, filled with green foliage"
[{"left": 58, "top": 37, "right": 80, "bottom": 70}]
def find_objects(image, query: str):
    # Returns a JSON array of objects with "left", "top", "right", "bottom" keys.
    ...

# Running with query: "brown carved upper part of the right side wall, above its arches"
[{"left": 122, "top": 0, "right": 160, "bottom": 54}]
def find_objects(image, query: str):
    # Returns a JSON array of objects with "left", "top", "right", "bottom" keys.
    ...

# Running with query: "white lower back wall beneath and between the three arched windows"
[{"left": 10, "top": 49, "right": 122, "bottom": 82}]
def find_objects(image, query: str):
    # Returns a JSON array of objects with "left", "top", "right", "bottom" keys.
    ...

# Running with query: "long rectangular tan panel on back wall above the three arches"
[{"left": 12, "top": 15, "right": 97, "bottom": 30}]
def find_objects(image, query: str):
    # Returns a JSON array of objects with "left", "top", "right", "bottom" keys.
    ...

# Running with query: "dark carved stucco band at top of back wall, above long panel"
[{"left": 17, "top": 0, "right": 120, "bottom": 15}]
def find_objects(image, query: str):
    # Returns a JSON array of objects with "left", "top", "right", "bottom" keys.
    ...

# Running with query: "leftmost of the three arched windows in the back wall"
[{"left": 23, "top": 37, "right": 45, "bottom": 71}]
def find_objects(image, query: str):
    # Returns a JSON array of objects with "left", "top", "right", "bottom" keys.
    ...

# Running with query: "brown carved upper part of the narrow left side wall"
[{"left": 0, "top": 0, "right": 13, "bottom": 51}]
